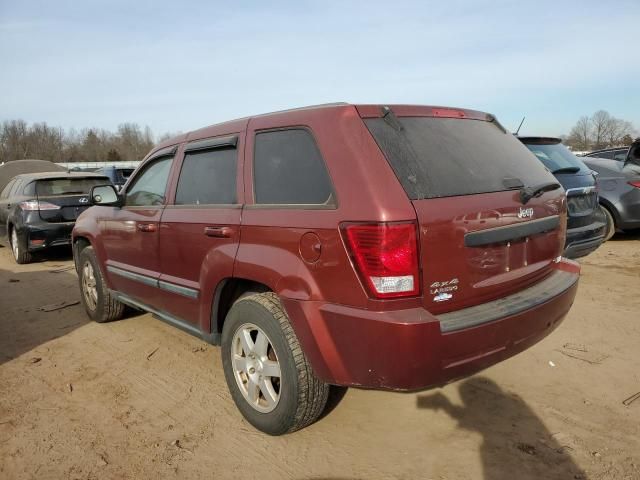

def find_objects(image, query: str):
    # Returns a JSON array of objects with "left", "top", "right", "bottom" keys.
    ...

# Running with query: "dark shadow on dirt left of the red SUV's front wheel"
[{"left": 0, "top": 268, "right": 89, "bottom": 365}]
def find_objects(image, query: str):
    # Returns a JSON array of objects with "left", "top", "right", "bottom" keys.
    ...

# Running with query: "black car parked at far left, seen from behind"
[{"left": 0, "top": 172, "right": 110, "bottom": 263}]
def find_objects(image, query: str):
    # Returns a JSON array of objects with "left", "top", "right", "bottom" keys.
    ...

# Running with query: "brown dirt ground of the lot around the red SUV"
[{"left": 0, "top": 235, "right": 640, "bottom": 480}]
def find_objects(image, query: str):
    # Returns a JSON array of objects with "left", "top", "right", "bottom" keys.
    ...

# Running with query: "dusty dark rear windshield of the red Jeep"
[{"left": 365, "top": 117, "right": 554, "bottom": 200}]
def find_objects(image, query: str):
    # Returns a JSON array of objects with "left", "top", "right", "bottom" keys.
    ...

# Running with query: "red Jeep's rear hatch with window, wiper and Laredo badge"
[{"left": 359, "top": 107, "right": 566, "bottom": 314}]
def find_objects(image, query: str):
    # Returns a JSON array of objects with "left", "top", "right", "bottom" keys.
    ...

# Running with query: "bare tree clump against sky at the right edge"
[{"left": 563, "top": 110, "right": 636, "bottom": 151}]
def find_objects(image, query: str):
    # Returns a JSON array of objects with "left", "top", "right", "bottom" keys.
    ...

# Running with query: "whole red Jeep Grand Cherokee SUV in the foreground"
[{"left": 73, "top": 104, "right": 579, "bottom": 435}]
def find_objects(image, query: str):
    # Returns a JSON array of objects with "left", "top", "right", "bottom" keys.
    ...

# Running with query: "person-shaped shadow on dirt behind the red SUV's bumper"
[{"left": 417, "top": 377, "right": 587, "bottom": 480}]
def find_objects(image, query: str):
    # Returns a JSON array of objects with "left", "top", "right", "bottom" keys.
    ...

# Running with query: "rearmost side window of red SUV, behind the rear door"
[{"left": 253, "top": 128, "right": 334, "bottom": 205}]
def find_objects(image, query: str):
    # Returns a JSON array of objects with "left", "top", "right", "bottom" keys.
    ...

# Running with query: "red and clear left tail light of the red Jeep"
[{"left": 342, "top": 222, "right": 420, "bottom": 298}]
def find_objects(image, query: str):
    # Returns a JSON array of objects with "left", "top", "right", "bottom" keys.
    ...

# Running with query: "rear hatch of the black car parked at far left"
[{"left": 35, "top": 176, "right": 111, "bottom": 223}]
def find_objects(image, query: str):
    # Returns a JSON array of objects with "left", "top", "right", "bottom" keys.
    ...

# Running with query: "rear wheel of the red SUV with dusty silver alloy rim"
[{"left": 222, "top": 292, "right": 329, "bottom": 435}]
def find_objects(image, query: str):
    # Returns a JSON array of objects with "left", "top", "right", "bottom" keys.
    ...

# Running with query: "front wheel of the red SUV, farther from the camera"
[{"left": 78, "top": 247, "right": 125, "bottom": 323}]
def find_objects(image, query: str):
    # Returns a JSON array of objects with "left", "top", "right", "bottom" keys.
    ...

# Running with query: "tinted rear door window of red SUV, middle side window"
[{"left": 175, "top": 148, "right": 238, "bottom": 205}]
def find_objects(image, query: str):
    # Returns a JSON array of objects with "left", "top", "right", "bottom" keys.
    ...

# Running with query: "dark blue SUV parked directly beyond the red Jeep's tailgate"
[{"left": 519, "top": 137, "right": 607, "bottom": 258}]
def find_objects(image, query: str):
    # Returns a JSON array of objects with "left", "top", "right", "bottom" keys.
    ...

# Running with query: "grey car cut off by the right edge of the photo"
[{"left": 584, "top": 139, "right": 640, "bottom": 237}]
